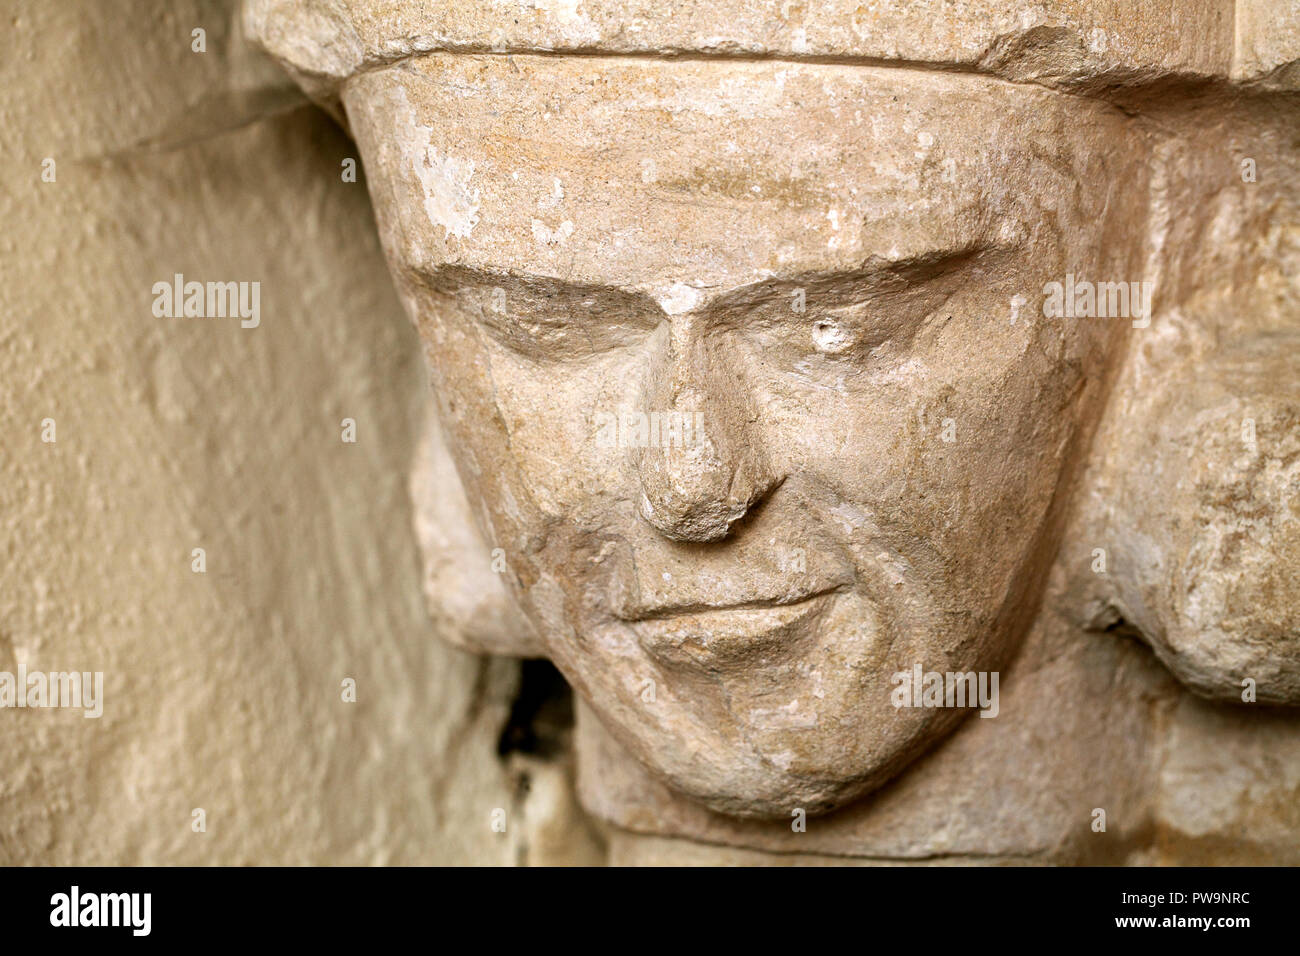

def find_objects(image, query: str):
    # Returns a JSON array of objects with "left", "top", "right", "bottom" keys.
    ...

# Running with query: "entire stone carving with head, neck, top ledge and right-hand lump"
[{"left": 246, "top": 0, "right": 1300, "bottom": 862}]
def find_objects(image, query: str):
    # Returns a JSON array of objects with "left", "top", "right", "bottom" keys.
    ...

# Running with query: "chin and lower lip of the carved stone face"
[{"left": 569, "top": 591, "right": 996, "bottom": 819}]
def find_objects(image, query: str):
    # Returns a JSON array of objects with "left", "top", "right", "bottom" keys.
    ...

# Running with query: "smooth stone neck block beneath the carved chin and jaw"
[{"left": 579, "top": 574, "right": 1177, "bottom": 864}]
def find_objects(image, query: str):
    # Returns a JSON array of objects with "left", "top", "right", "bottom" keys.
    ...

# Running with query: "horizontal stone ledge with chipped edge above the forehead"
[{"left": 247, "top": 0, "right": 1237, "bottom": 99}]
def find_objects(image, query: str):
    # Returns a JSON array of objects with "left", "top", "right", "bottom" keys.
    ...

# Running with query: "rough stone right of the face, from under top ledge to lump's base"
[{"left": 1078, "top": 99, "right": 1300, "bottom": 704}]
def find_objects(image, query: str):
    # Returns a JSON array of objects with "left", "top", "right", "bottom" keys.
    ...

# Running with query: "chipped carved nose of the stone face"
[{"left": 632, "top": 319, "right": 780, "bottom": 541}]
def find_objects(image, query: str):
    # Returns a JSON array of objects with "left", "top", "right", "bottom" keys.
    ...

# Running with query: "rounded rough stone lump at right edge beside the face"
[{"left": 1084, "top": 330, "right": 1300, "bottom": 706}]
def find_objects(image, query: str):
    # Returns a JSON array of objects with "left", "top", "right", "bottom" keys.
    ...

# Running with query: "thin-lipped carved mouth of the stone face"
[{"left": 628, "top": 591, "right": 837, "bottom": 670}]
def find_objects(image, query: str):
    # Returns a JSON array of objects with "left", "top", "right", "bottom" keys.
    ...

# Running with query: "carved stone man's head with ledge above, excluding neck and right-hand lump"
[{"left": 248, "top": 0, "right": 1296, "bottom": 817}]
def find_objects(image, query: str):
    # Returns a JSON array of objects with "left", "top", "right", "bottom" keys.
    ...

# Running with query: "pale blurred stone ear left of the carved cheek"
[{"left": 411, "top": 401, "right": 545, "bottom": 657}]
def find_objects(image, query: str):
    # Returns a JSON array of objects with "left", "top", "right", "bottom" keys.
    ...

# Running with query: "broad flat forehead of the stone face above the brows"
[{"left": 343, "top": 55, "right": 1122, "bottom": 307}]
